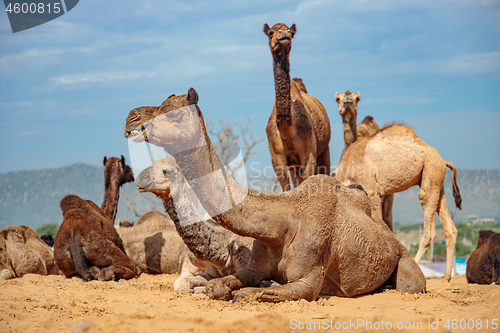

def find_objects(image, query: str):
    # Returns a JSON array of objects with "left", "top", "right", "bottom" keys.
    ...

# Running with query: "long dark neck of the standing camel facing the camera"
[{"left": 273, "top": 54, "right": 292, "bottom": 131}]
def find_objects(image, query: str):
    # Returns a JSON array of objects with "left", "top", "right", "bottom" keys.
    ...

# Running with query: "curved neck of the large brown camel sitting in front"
[{"left": 168, "top": 130, "right": 283, "bottom": 243}]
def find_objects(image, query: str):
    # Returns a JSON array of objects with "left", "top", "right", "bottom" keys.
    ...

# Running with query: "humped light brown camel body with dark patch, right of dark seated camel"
[{"left": 117, "top": 211, "right": 205, "bottom": 292}]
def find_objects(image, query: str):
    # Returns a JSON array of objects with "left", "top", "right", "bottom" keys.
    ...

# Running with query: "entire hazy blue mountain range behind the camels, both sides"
[{"left": 0, "top": 163, "right": 500, "bottom": 229}]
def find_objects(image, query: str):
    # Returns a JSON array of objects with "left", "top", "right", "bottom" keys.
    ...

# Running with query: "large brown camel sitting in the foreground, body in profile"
[{"left": 124, "top": 88, "right": 425, "bottom": 302}]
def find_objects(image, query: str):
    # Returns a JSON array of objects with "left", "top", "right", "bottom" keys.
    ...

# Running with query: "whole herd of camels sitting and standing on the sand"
[{"left": 0, "top": 23, "right": 500, "bottom": 302}]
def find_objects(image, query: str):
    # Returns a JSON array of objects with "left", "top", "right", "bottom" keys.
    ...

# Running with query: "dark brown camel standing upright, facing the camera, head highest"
[{"left": 264, "top": 23, "right": 331, "bottom": 191}]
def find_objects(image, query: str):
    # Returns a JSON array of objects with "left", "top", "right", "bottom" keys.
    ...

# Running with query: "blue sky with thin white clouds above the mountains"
[{"left": 0, "top": 0, "right": 500, "bottom": 173}]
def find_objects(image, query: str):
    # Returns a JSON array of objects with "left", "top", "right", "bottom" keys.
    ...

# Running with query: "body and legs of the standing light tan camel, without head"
[{"left": 335, "top": 124, "right": 462, "bottom": 280}]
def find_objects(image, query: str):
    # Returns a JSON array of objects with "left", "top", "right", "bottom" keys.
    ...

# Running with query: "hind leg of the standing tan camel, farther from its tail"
[{"left": 415, "top": 184, "right": 442, "bottom": 264}]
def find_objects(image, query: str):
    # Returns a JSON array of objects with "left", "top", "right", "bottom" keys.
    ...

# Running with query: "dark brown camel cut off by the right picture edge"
[{"left": 466, "top": 230, "right": 500, "bottom": 285}]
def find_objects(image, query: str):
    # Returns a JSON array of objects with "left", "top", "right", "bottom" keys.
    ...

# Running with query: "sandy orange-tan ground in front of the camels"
[{"left": 0, "top": 274, "right": 500, "bottom": 333}]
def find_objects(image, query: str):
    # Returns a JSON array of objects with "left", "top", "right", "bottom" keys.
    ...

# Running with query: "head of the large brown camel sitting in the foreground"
[{"left": 124, "top": 88, "right": 206, "bottom": 155}]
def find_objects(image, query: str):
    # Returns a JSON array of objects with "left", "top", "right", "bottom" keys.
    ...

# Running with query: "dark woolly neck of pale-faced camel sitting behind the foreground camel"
[{"left": 160, "top": 191, "right": 229, "bottom": 267}]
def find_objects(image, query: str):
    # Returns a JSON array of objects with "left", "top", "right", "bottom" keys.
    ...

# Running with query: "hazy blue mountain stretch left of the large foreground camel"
[{"left": 0, "top": 163, "right": 164, "bottom": 229}]
